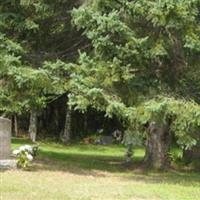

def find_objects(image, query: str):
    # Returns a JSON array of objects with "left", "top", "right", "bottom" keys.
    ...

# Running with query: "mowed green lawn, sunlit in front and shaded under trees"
[{"left": 0, "top": 139, "right": 200, "bottom": 200}]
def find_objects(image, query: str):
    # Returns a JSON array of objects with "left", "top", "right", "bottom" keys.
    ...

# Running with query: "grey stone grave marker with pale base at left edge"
[{"left": 0, "top": 117, "right": 16, "bottom": 168}]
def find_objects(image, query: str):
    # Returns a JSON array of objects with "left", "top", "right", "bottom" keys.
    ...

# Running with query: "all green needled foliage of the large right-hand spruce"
[{"left": 69, "top": 0, "right": 200, "bottom": 151}]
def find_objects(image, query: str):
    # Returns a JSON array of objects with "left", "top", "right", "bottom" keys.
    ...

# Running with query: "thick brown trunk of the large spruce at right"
[{"left": 144, "top": 122, "right": 170, "bottom": 169}]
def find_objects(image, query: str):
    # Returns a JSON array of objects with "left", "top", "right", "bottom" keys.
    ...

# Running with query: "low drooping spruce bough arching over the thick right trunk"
[{"left": 130, "top": 97, "right": 200, "bottom": 149}]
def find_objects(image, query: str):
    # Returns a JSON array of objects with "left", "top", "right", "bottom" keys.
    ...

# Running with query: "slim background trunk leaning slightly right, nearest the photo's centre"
[{"left": 61, "top": 109, "right": 72, "bottom": 144}]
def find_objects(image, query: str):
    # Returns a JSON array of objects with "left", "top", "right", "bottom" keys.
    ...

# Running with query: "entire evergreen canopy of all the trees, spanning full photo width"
[{"left": 0, "top": 0, "right": 200, "bottom": 169}]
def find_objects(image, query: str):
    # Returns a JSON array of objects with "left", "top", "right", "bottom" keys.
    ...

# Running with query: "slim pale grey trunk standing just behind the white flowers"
[{"left": 28, "top": 110, "right": 37, "bottom": 142}]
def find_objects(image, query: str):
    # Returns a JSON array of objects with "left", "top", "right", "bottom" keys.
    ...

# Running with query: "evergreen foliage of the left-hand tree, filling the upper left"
[{"left": 0, "top": 0, "right": 82, "bottom": 115}]
